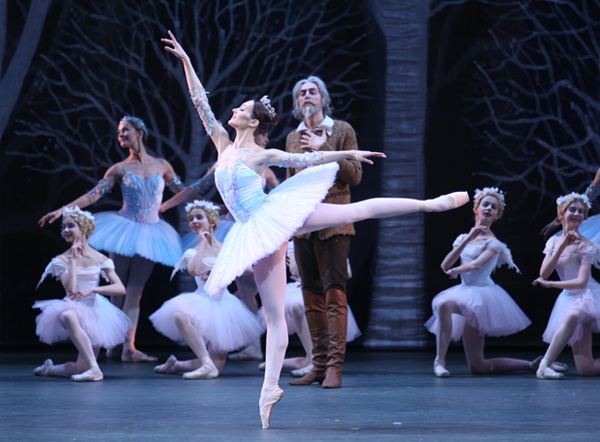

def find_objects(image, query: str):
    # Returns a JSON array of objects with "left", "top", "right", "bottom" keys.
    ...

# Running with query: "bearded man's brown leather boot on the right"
[{"left": 323, "top": 289, "right": 348, "bottom": 388}]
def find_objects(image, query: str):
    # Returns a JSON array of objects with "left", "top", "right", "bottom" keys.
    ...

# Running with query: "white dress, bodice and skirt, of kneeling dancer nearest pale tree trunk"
[{"left": 425, "top": 234, "right": 531, "bottom": 341}]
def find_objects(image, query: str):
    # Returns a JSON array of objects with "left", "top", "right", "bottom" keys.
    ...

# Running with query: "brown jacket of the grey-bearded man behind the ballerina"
[{"left": 285, "top": 120, "right": 362, "bottom": 240}]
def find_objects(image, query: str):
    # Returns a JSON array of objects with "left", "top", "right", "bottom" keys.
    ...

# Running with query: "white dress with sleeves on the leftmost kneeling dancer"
[{"left": 33, "top": 258, "right": 132, "bottom": 348}]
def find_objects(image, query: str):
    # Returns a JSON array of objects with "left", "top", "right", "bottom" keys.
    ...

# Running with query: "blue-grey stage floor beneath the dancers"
[{"left": 0, "top": 347, "right": 600, "bottom": 442}]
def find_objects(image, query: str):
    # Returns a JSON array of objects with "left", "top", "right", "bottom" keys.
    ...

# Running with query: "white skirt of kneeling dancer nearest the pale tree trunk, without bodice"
[{"left": 425, "top": 284, "right": 531, "bottom": 341}]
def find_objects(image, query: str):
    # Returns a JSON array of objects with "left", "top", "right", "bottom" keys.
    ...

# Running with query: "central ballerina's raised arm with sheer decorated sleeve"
[{"left": 161, "top": 31, "right": 230, "bottom": 153}]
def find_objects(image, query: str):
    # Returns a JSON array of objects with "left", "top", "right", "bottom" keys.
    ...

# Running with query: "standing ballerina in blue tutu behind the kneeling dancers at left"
[{"left": 38, "top": 116, "right": 184, "bottom": 362}]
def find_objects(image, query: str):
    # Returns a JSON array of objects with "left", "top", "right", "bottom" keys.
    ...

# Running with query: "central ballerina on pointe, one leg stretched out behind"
[{"left": 162, "top": 32, "right": 469, "bottom": 428}]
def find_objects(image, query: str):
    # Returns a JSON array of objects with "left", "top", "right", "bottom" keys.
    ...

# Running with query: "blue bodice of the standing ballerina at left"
[{"left": 119, "top": 172, "right": 165, "bottom": 224}]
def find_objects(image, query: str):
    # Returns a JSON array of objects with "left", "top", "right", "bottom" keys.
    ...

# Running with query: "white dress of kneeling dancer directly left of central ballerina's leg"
[{"left": 150, "top": 249, "right": 264, "bottom": 353}]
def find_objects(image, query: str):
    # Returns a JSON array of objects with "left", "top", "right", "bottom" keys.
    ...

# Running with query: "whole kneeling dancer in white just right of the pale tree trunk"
[{"left": 425, "top": 187, "right": 552, "bottom": 377}]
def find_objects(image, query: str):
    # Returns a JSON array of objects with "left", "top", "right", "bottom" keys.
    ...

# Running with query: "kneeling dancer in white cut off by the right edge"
[{"left": 533, "top": 193, "right": 600, "bottom": 379}]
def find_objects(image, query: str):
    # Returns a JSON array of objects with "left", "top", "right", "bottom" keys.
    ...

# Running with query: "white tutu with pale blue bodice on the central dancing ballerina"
[{"left": 206, "top": 161, "right": 339, "bottom": 295}]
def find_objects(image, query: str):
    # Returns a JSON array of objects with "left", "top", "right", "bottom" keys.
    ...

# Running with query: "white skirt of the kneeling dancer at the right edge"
[{"left": 542, "top": 284, "right": 600, "bottom": 345}]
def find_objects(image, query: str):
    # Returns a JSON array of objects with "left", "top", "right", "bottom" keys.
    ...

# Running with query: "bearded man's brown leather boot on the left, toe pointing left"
[{"left": 290, "top": 289, "right": 329, "bottom": 385}]
